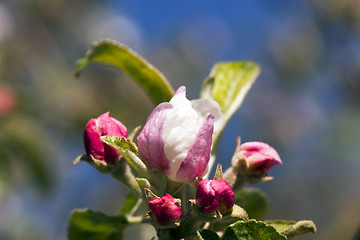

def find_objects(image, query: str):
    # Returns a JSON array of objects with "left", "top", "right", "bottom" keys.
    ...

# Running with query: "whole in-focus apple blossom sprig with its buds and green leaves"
[{"left": 71, "top": 40, "right": 316, "bottom": 240}]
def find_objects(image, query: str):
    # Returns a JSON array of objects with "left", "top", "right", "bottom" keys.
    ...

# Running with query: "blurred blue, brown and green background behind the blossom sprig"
[{"left": 0, "top": 0, "right": 360, "bottom": 240}]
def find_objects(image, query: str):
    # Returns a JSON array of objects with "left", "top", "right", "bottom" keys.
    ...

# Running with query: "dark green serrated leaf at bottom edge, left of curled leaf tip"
[{"left": 221, "top": 220, "right": 286, "bottom": 240}]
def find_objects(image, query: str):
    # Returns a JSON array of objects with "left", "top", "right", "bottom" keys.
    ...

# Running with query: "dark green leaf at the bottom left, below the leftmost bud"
[{"left": 68, "top": 209, "right": 130, "bottom": 240}]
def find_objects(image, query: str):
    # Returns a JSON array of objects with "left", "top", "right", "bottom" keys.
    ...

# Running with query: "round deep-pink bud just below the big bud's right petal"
[{"left": 196, "top": 179, "right": 235, "bottom": 214}]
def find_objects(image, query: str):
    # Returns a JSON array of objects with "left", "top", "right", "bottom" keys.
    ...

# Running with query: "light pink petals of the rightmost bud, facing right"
[{"left": 240, "top": 142, "right": 282, "bottom": 173}]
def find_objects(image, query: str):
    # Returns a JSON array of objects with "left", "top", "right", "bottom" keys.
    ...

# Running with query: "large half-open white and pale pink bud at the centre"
[{"left": 137, "top": 87, "right": 221, "bottom": 182}]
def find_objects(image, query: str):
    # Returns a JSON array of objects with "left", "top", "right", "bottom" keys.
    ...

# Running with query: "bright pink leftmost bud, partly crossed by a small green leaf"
[{"left": 84, "top": 112, "right": 127, "bottom": 163}]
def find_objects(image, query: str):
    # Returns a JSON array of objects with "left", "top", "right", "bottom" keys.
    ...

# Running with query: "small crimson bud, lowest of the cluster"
[{"left": 149, "top": 193, "right": 182, "bottom": 226}]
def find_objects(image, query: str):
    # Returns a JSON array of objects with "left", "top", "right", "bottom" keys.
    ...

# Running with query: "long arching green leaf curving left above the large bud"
[{"left": 74, "top": 39, "right": 174, "bottom": 105}]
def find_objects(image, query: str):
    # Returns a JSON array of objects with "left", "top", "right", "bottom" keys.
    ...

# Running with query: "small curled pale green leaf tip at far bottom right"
[{"left": 270, "top": 220, "right": 316, "bottom": 239}]
